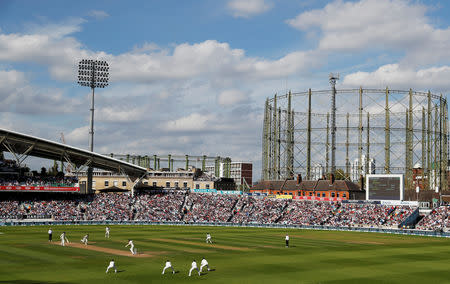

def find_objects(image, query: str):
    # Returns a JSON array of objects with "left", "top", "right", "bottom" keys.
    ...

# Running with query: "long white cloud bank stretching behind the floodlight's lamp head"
[{"left": 0, "top": 24, "right": 319, "bottom": 83}]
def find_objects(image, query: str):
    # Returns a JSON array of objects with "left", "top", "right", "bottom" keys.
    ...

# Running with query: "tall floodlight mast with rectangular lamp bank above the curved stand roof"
[{"left": 78, "top": 59, "right": 109, "bottom": 193}]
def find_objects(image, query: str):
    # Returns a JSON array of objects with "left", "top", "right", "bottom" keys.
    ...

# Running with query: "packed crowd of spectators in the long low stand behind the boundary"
[{"left": 0, "top": 191, "right": 436, "bottom": 230}]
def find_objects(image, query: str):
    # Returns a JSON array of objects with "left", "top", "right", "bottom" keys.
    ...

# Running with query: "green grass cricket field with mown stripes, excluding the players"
[{"left": 0, "top": 226, "right": 450, "bottom": 284}]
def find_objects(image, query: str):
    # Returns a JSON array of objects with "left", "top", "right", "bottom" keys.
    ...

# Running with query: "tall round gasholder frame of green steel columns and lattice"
[{"left": 261, "top": 88, "right": 448, "bottom": 190}]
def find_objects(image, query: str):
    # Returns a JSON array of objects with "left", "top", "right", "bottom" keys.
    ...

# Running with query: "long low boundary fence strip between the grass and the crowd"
[{"left": 0, "top": 220, "right": 450, "bottom": 238}]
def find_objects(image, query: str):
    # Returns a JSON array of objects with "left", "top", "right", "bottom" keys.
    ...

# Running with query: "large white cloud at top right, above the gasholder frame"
[{"left": 287, "top": 0, "right": 450, "bottom": 65}]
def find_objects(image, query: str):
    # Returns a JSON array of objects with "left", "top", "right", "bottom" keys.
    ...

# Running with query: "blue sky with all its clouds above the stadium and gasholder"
[{"left": 0, "top": 0, "right": 450, "bottom": 178}]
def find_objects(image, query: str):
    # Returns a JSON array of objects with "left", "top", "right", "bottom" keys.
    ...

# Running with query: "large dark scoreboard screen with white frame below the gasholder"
[{"left": 366, "top": 174, "right": 403, "bottom": 200}]
